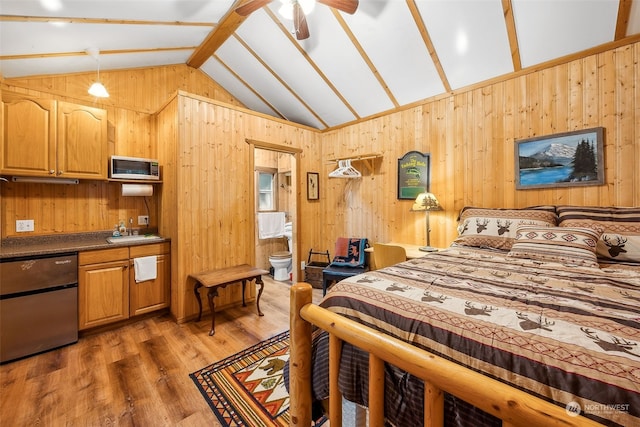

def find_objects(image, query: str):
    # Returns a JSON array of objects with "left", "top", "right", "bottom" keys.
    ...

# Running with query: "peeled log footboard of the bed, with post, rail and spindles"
[{"left": 289, "top": 283, "right": 601, "bottom": 427}]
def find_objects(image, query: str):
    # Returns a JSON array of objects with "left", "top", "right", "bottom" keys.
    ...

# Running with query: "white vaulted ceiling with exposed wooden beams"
[{"left": 0, "top": 0, "right": 640, "bottom": 129}]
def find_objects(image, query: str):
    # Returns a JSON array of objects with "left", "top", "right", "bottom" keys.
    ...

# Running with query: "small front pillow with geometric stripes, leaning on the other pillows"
[{"left": 507, "top": 226, "right": 602, "bottom": 267}]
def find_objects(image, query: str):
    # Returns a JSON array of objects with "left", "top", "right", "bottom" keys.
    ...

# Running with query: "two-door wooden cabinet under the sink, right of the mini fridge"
[{"left": 78, "top": 242, "right": 171, "bottom": 330}]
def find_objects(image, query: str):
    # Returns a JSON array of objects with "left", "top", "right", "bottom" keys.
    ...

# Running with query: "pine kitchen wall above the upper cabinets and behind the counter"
[{"left": 0, "top": 65, "right": 240, "bottom": 238}]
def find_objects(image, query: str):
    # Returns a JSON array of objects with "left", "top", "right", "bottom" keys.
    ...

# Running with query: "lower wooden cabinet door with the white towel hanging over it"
[{"left": 129, "top": 255, "right": 171, "bottom": 316}]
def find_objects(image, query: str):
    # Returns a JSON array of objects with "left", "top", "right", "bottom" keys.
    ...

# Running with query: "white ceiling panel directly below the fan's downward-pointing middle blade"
[{"left": 300, "top": 5, "right": 393, "bottom": 117}]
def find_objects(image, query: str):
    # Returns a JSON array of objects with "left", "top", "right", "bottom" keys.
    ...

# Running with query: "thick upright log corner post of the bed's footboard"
[{"left": 289, "top": 283, "right": 313, "bottom": 427}]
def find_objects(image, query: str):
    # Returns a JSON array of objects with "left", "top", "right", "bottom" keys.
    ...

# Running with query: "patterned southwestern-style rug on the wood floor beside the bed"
[{"left": 189, "top": 331, "right": 302, "bottom": 427}]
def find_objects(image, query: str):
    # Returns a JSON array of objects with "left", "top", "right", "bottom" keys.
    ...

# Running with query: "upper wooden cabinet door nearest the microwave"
[{"left": 56, "top": 101, "right": 108, "bottom": 179}]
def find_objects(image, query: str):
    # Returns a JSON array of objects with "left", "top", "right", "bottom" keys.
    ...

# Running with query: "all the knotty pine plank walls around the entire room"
[{"left": 0, "top": 43, "right": 640, "bottom": 319}]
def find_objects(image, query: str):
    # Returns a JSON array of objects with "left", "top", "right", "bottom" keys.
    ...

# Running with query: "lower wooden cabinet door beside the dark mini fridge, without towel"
[{"left": 78, "top": 259, "right": 129, "bottom": 330}]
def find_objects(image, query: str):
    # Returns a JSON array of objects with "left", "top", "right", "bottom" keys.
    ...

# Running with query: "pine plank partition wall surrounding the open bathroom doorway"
[{"left": 157, "top": 93, "right": 321, "bottom": 321}]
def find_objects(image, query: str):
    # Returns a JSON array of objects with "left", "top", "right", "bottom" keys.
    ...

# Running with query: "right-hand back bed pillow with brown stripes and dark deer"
[{"left": 557, "top": 206, "right": 640, "bottom": 263}]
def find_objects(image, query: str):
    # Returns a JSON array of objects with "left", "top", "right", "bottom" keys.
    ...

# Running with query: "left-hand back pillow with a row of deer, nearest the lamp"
[{"left": 454, "top": 206, "right": 556, "bottom": 250}]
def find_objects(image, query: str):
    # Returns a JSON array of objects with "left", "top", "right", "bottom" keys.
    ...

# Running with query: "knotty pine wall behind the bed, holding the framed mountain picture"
[{"left": 318, "top": 43, "right": 640, "bottom": 253}]
